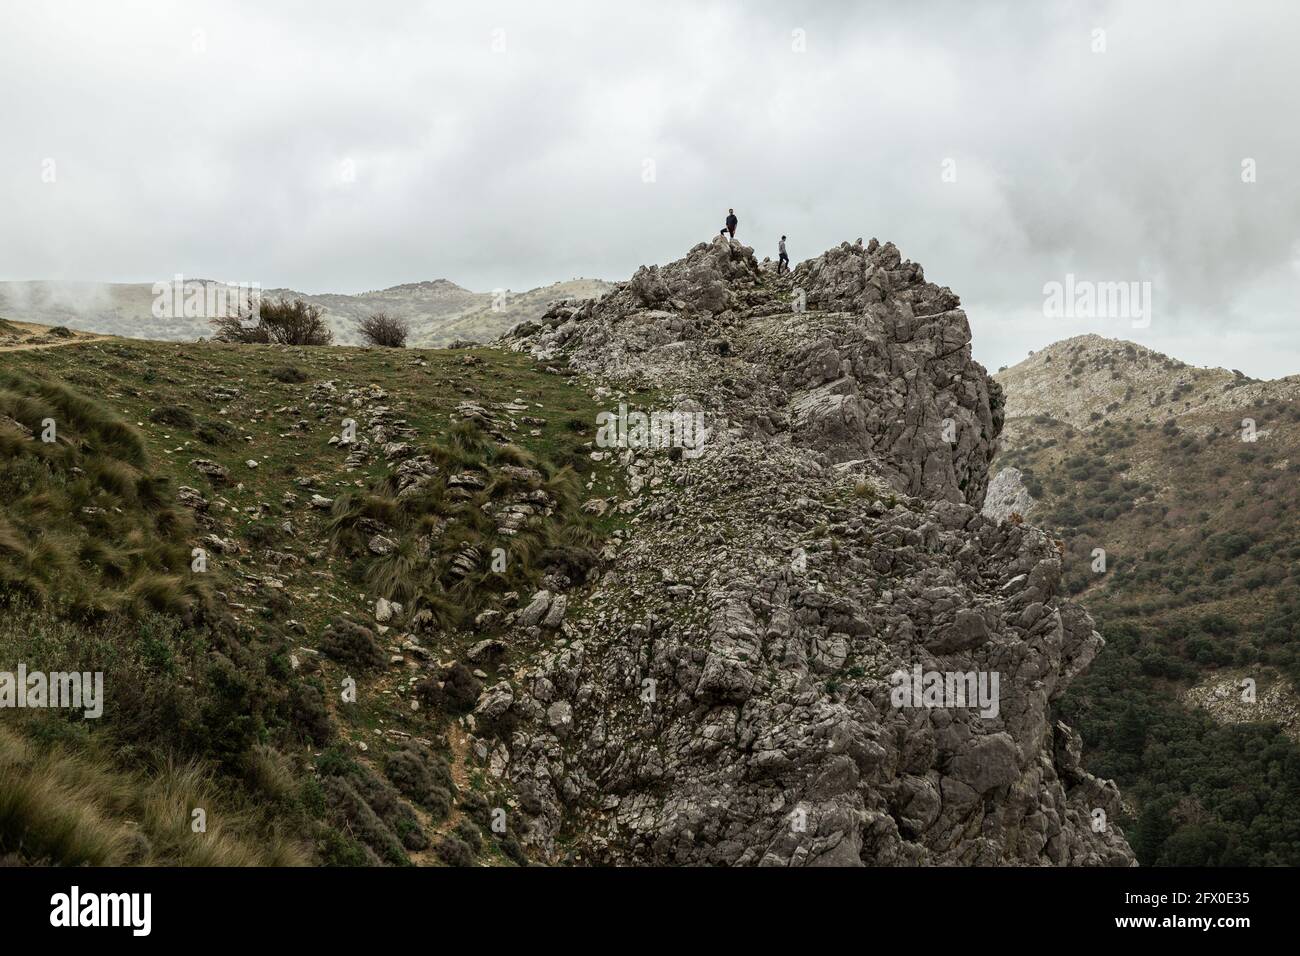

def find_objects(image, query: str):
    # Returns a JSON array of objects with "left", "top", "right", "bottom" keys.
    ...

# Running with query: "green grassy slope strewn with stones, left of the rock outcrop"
[{"left": 0, "top": 330, "right": 644, "bottom": 865}]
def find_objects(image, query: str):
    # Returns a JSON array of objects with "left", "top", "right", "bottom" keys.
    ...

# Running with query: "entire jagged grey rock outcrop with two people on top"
[{"left": 483, "top": 239, "right": 1132, "bottom": 866}]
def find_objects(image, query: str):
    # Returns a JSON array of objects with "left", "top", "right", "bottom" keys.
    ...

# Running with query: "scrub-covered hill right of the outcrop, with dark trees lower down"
[{"left": 993, "top": 336, "right": 1300, "bottom": 865}]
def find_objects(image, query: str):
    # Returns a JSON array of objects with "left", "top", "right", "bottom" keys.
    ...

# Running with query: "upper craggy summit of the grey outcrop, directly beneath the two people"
[{"left": 511, "top": 238, "right": 1002, "bottom": 507}]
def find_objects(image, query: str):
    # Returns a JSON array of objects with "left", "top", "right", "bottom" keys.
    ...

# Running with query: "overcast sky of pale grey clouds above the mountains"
[{"left": 0, "top": 0, "right": 1300, "bottom": 377}]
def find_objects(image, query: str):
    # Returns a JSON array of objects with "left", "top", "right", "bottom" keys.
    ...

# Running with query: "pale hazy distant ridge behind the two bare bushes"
[{"left": 0, "top": 278, "right": 612, "bottom": 346}]
